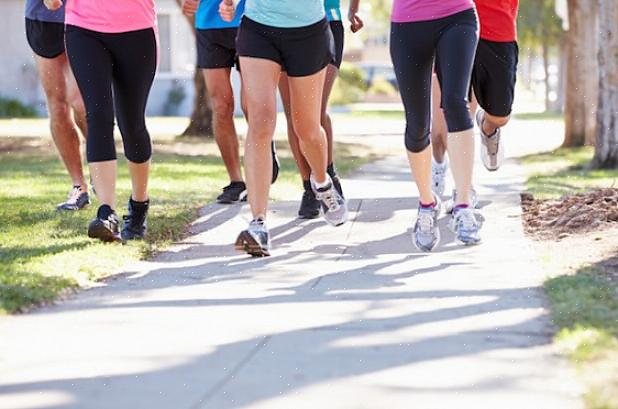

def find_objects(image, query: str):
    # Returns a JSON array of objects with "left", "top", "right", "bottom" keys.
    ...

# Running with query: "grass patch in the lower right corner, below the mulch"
[{"left": 545, "top": 267, "right": 618, "bottom": 409}]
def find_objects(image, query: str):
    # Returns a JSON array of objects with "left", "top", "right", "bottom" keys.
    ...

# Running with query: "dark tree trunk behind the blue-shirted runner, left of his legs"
[{"left": 176, "top": 0, "right": 214, "bottom": 137}]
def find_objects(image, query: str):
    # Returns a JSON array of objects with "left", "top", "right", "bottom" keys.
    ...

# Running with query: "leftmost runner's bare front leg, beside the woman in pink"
[{"left": 35, "top": 54, "right": 88, "bottom": 192}]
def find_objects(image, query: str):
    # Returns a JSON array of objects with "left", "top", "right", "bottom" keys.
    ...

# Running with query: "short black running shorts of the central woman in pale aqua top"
[{"left": 236, "top": 16, "right": 335, "bottom": 77}]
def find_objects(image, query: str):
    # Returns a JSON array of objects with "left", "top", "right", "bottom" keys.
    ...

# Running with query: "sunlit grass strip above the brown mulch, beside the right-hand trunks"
[{"left": 521, "top": 147, "right": 618, "bottom": 199}]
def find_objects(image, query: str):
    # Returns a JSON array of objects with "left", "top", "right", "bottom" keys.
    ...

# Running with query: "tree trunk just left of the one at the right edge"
[{"left": 563, "top": 0, "right": 596, "bottom": 147}]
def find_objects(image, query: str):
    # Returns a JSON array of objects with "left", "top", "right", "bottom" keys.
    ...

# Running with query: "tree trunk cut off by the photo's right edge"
[{"left": 592, "top": 0, "right": 618, "bottom": 169}]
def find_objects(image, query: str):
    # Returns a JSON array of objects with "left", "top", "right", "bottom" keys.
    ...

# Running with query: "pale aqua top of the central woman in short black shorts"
[{"left": 245, "top": 0, "right": 326, "bottom": 28}]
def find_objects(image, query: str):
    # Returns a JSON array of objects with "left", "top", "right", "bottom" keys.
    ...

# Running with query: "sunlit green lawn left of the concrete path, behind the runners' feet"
[{"left": 0, "top": 138, "right": 374, "bottom": 314}]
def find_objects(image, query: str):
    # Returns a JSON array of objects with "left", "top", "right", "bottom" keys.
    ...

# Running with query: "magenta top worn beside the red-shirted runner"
[{"left": 392, "top": 0, "right": 474, "bottom": 23}]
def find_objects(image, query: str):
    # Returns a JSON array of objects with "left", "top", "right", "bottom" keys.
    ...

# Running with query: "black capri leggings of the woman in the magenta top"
[{"left": 391, "top": 9, "right": 478, "bottom": 153}]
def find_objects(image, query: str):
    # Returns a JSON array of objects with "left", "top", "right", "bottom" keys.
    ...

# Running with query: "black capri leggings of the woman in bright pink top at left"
[{"left": 66, "top": 25, "right": 157, "bottom": 163}]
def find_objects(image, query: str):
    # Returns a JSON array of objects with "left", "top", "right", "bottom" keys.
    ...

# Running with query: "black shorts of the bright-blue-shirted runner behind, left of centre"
[{"left": 197, "top": 28, "right": 238, "bottom": 69}]
